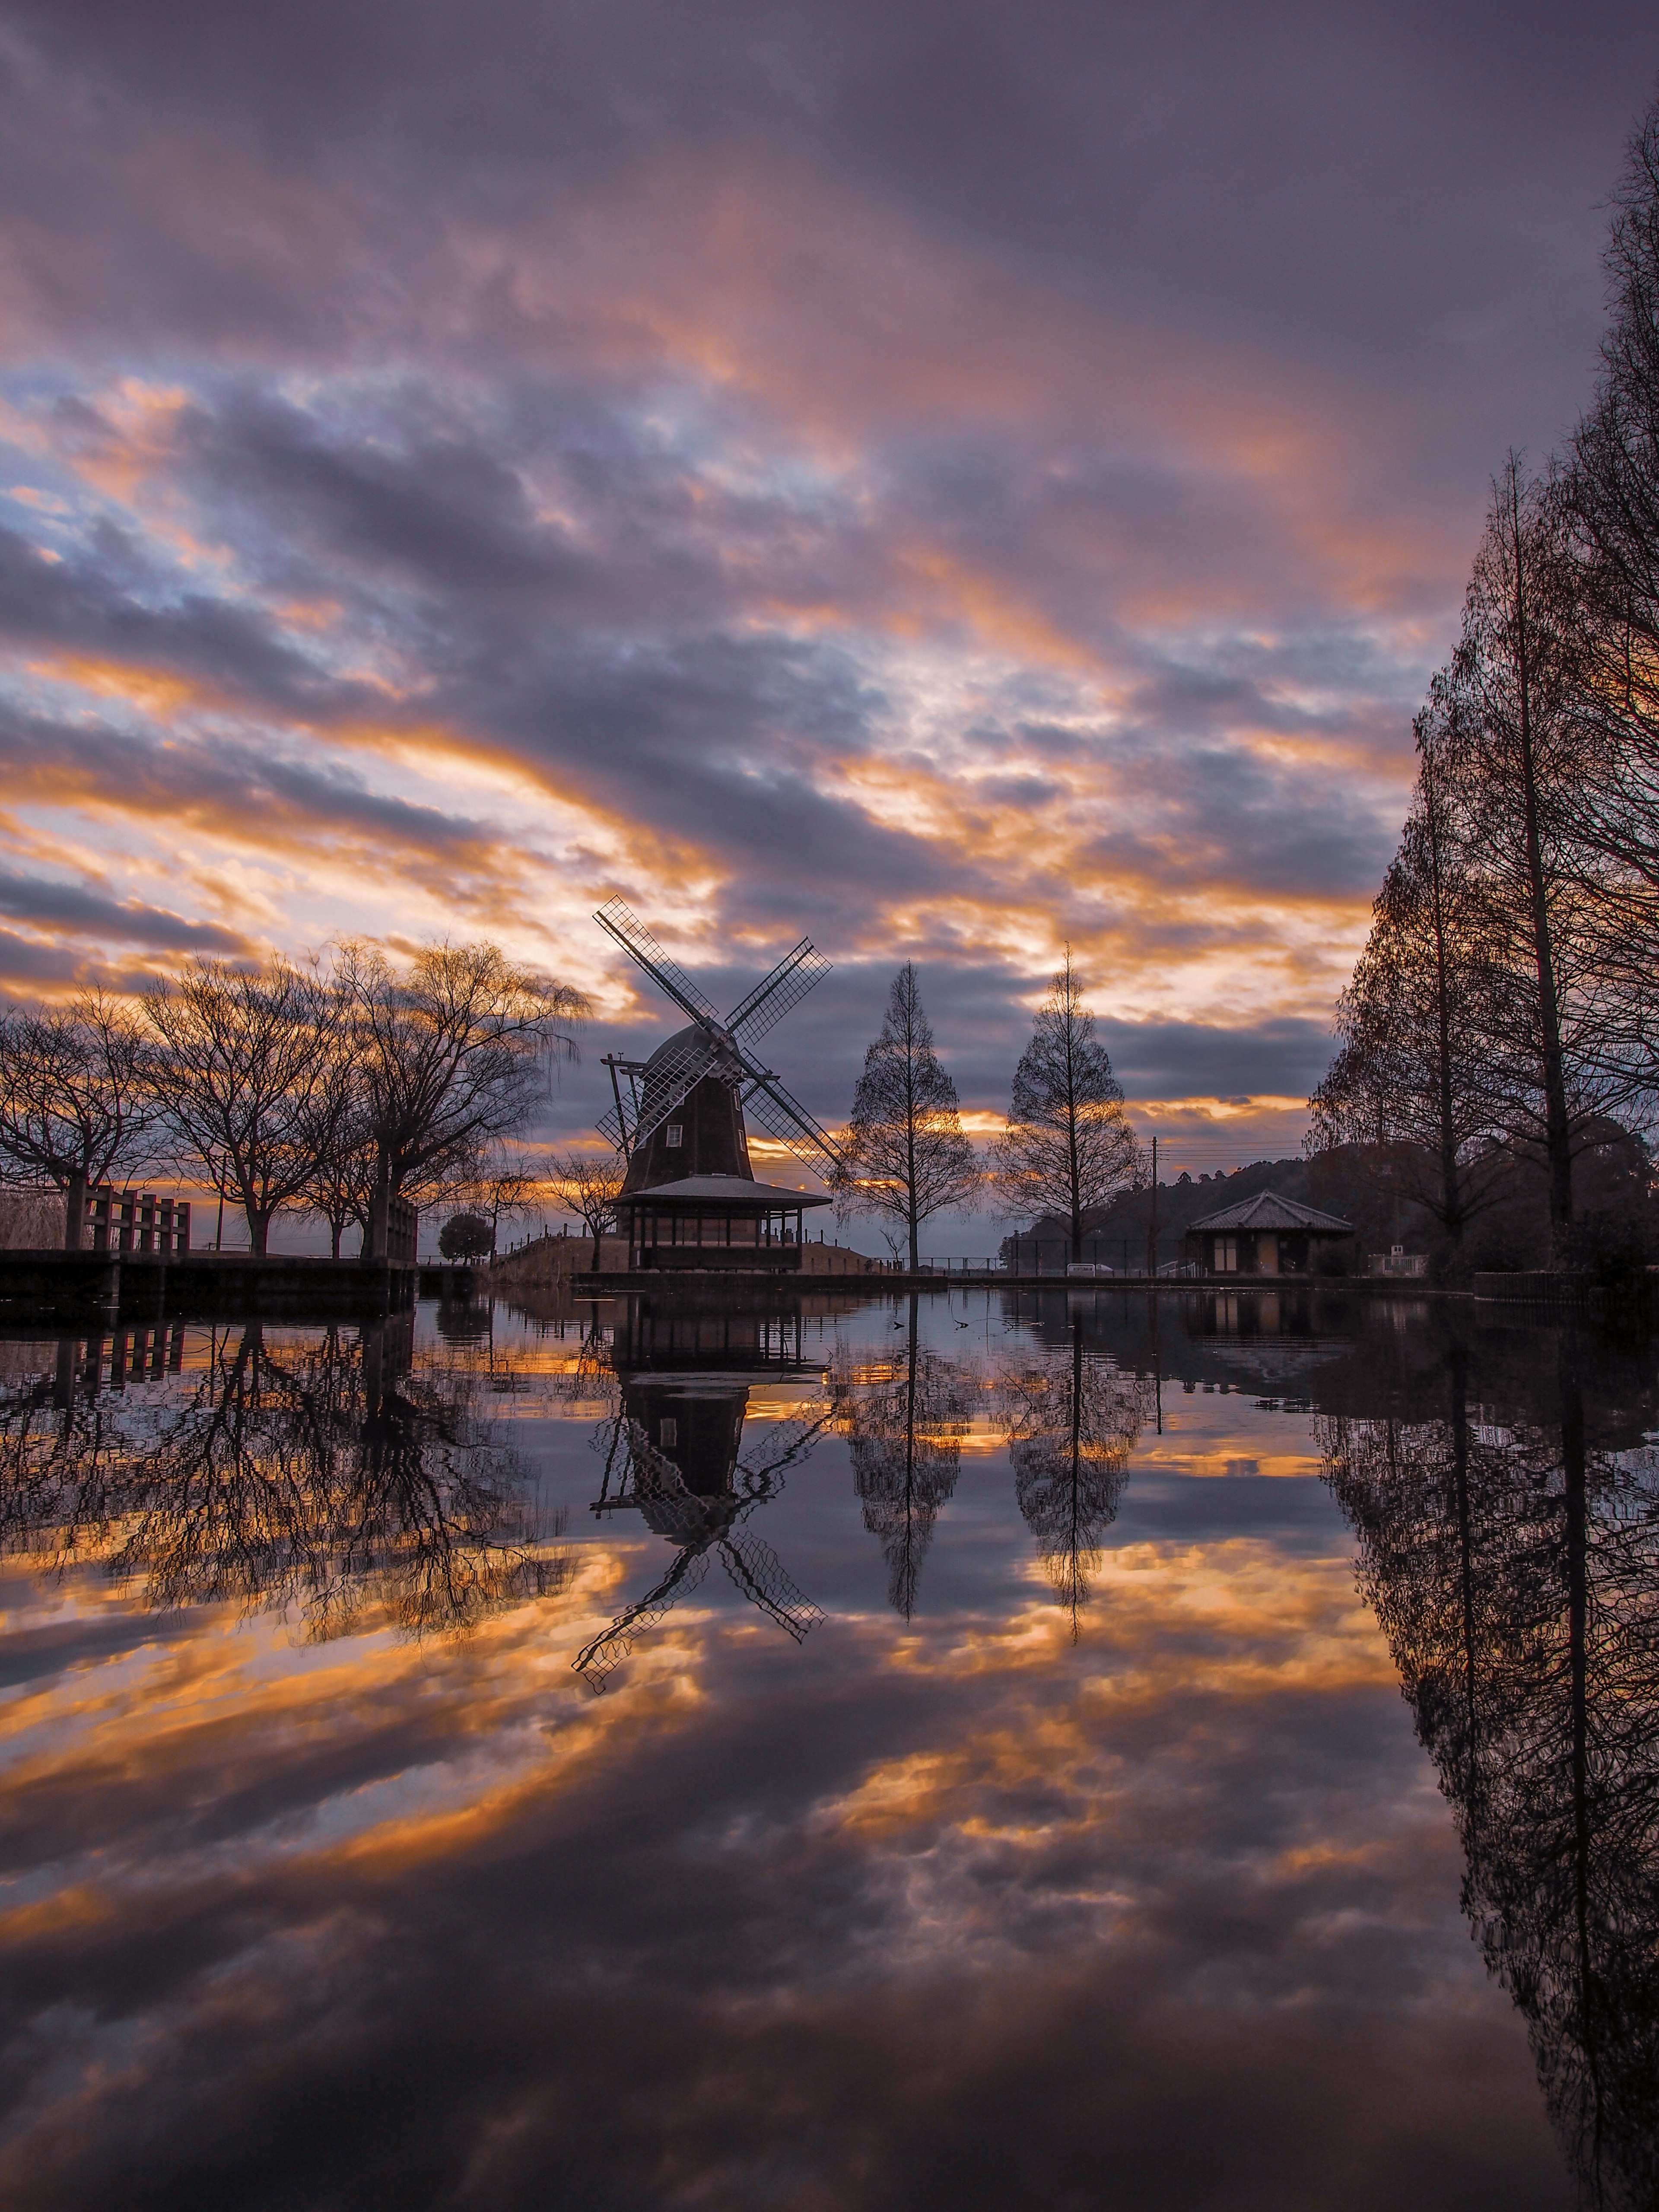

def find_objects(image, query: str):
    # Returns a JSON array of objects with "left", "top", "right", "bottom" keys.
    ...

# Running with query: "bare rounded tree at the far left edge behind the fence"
[{"left": 0, "top": 989, "right": 155, "bottom": 1252}]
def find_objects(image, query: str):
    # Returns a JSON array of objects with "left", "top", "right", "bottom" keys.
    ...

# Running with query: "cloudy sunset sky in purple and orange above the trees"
[{"left": 0, "top": 0, "right": 1659, "bottom": 1168}]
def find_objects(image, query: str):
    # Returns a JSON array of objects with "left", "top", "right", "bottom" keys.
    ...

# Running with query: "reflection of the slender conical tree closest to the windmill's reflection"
[{"left": 836, "top": 1292, "right": 978, "bottom": 1619}]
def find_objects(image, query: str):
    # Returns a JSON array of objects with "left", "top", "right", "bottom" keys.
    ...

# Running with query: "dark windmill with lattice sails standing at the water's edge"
[{"left": 595, "top": 898, "right": 841, "bottom": 1272}]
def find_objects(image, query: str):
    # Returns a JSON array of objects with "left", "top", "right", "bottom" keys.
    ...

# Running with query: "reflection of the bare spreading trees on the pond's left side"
[{"left": 0, "top": 1316, "right": 569, "bottom": 1641}]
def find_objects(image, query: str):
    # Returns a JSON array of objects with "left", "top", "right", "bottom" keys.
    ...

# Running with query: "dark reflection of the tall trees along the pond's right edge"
[{"left": 1321, "top": 1332, "right": 1659, "bottom": 2208}]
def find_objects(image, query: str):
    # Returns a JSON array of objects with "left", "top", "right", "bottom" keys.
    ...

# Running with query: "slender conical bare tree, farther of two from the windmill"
[{"left": 993, "top": 944, "right": 1141, "bottom": 1261}]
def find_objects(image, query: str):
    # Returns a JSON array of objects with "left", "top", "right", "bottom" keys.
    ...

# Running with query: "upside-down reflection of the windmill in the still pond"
[{"left": 573, "top": 1298, "right": 830, "bottom": 1694}]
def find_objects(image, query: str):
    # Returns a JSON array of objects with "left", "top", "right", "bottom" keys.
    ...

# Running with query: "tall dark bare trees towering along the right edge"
[{"left": 1312, "top": 104, "right": 1659, "bottom": 1265}]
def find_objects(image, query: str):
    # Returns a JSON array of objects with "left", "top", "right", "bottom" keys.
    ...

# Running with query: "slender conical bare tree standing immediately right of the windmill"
[{"left": 836, "top": 960, "right": 980, "bottom": 1272}]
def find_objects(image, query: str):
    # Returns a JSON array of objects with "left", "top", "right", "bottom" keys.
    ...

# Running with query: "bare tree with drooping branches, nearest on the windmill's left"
[{"left": 338, "top": 942, "right": 588, "bottom": 1259}]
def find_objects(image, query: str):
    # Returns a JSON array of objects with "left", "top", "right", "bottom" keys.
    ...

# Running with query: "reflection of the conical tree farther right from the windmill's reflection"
[{"left": 1000, "top": 1314, "right": 1155, "bottom": 1641}]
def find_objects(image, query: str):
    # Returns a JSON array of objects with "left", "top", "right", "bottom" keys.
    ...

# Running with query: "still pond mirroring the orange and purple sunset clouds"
[{"left": 0, "top": 1290, "right": 1659, "bottom": 2212}]
